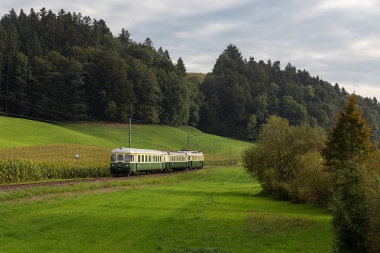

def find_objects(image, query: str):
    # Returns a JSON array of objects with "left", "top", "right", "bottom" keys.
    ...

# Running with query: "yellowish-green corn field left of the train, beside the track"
[{"left": 0, "top": 144, "right": 110, "bottom": 184}]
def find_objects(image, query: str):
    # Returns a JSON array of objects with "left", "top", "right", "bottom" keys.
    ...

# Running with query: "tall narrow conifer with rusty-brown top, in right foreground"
[{"left": 322, "top": 94, "right": 372, "bottom": 252}]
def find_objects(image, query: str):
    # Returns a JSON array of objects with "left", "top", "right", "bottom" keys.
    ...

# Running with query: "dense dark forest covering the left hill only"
[{"left": 0, "top": 8, "right": 202, "bottom": 126}]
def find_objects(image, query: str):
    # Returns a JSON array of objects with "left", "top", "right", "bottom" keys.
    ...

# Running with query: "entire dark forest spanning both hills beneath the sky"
[{"left": 0, "top": 8, "right": 380, "bottom": 140}]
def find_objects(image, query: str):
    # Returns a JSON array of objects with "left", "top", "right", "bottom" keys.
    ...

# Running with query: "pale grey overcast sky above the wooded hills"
[{"left": 0, "top": 0, "right": 380, "bottom": 101}]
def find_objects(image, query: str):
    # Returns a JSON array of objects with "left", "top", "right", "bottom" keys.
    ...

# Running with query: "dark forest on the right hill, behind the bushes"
[{"left": 200, "top": 44, "right": 380, "bottom": 139}]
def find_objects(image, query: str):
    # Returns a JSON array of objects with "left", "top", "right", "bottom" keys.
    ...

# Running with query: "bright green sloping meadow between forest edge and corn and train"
[{"left": 0, "top": 116, "right": 249, "bottom": 160}]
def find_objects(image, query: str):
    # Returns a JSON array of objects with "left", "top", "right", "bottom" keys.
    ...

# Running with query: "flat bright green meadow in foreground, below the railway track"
[{"left": 0, "top": 168, "right": 332, "bottom": 253}]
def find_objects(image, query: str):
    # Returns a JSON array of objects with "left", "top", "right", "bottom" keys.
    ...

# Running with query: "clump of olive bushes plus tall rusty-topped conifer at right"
[{"left": 243, "top": 94, "right": 380, "bottom": 252}]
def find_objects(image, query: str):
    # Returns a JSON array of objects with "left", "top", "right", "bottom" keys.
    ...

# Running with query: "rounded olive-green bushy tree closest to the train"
[{"left": 242, "top": 116, "right": 325, "bottom": 200}]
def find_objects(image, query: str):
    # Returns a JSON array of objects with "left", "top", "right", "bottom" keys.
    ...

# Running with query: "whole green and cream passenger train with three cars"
[{"left": 110, "top": 147, "right": 204, "bottom": 176}]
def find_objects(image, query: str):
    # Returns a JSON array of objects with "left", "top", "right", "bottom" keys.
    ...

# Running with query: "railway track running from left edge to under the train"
[{"left": 0, "top": 170, "right": 189, "bottom": 191}]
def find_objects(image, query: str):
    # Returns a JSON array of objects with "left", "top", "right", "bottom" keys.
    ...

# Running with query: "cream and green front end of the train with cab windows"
[{"left": 110, "top": 147, "right": 134, "bottom": 176}]
